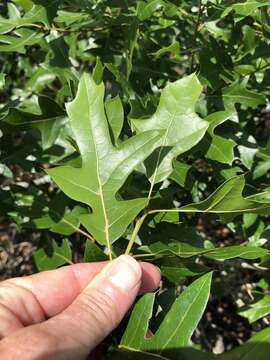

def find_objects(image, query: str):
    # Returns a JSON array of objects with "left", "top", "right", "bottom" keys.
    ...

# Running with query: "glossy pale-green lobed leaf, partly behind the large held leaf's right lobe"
[{"left": 131, "top": 74, "right": 208, "bottom": 184}]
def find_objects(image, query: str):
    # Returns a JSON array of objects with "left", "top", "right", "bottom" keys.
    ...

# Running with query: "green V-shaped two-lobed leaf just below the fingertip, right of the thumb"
[{"left": 120, "top": 273, "right": 212, "bottom": 356}]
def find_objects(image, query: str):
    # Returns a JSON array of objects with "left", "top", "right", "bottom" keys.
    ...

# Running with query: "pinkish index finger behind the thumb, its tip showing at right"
[{"left": 0, "top": 262, "right": 160, "bottom": 338}]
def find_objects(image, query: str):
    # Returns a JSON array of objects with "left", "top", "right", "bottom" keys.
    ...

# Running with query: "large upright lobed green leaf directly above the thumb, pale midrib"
[{"left": 48, "top": 74, "right": 160, "bottom": 247}]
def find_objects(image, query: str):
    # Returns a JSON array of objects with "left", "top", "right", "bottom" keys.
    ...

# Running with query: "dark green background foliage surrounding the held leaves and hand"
[{"left": 0, "top": 0, "right": 270, "bottom": 359}]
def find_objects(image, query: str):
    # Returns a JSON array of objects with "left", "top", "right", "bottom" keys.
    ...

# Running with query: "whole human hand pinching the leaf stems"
[{"left": 0, "top": 255, "right": 160, "bottom": 360}]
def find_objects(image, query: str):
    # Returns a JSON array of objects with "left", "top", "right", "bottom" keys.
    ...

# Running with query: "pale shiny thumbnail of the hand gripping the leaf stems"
[{"left": 104, "top": 255, "right": 142, "bottom": 292}]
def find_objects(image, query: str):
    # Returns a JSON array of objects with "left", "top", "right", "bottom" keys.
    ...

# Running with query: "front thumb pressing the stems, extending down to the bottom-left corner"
[{"left": 0, "top": 256, "right": 148, "bottom": 359}]
